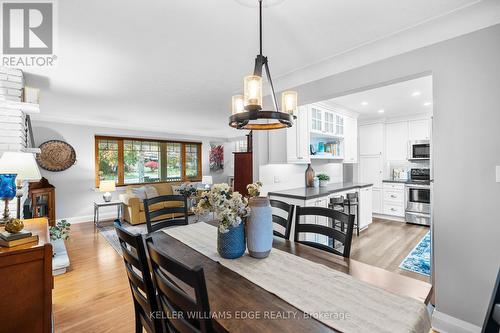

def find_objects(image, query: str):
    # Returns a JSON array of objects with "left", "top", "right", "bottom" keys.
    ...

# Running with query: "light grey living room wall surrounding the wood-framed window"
[{"left": 32, "top": 120, "right": 229, "bottom": 222}]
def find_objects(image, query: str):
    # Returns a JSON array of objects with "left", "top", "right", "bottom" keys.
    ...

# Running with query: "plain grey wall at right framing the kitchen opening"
[{"left": 282, "top": 25, "right": 500, "bottom": 332}]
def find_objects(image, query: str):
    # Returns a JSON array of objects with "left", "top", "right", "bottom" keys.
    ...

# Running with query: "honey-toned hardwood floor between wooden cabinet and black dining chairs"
[{"left": 52, "top": 222, "right": 135, "bottom": 333}]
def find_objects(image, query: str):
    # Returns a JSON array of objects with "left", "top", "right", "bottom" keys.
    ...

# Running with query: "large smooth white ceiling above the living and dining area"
[{"left": 26, "top": 0, "right": 500, "bottom": 137}]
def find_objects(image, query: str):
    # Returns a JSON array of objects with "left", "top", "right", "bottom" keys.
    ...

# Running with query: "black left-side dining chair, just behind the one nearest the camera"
[{"left": 115, "top": 222, "right": 163, "bottom": 333}]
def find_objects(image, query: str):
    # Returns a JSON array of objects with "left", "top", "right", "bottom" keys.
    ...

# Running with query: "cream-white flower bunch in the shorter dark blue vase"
[{"left": 193, "top": 183, "right": 250, "bottom": 233}]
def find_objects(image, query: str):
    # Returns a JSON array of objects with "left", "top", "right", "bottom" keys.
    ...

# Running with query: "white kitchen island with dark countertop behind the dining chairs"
[{"left": 268, "top": 182, "right": 373, "bottom": 239}]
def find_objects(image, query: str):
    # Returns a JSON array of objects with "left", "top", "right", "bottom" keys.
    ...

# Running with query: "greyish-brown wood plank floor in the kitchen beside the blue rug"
[{"left": 351, "top": 218, "right": 430, "bottom": 282}]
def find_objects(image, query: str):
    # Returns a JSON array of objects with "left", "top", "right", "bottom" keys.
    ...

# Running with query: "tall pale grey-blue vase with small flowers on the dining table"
[{"left": 246, "top": 182, "right": 273, "bottom": 259}]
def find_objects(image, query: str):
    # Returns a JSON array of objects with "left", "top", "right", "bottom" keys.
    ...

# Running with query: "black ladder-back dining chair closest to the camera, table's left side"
[{"left": 146, "top": 237, "right": 214, "bottom": 333}]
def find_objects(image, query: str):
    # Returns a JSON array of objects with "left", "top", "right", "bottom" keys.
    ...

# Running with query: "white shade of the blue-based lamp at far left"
[{"left": 0, "top": 152, "right": 42, "bottom": 181}]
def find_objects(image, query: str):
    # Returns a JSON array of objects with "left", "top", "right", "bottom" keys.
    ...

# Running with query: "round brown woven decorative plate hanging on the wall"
[{"left": 36, "top": 140, "right": 76, "bottom": 172}]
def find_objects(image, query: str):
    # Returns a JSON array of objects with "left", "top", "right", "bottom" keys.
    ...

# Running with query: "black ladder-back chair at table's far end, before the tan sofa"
[{"left": 144, "top": 195, "right": 188, "bottom": 233}]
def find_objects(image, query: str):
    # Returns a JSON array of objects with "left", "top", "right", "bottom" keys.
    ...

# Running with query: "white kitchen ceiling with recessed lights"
[{"left": 325, "top": 76, "right": 433, "bottom": 119}]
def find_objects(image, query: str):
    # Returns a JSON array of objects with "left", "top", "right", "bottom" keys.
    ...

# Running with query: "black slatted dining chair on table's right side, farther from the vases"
[{"left": 294, "top": 206, "right": 354, "bottom": 258}]
